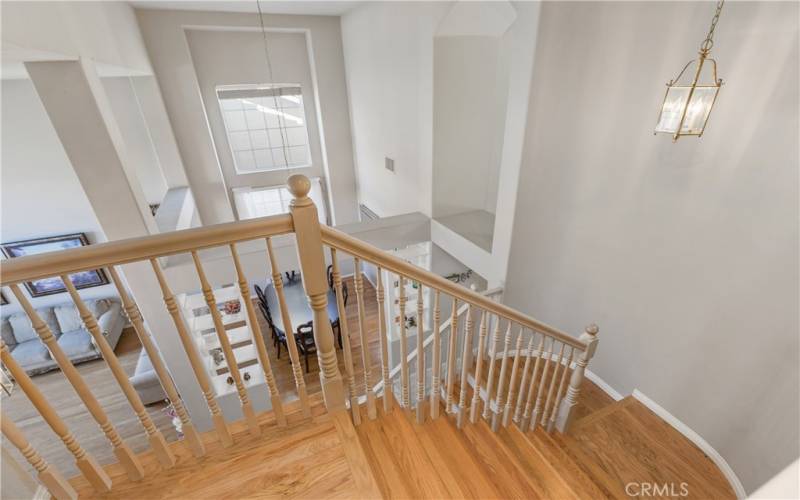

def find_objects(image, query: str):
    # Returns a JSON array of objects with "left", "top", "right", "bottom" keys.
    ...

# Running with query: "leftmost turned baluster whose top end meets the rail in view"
[{"left": 10, "top": 284, "right": 144, "bottom": 481}]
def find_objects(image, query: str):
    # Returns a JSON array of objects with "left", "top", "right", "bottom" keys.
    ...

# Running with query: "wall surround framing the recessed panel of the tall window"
[{"left": 136, "top": 10, "right": 358, "bottom": 224}]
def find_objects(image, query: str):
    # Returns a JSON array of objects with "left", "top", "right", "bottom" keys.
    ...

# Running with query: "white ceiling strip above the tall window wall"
[{"left": 129, "top": 0, "right": 361, "bottom": 16}]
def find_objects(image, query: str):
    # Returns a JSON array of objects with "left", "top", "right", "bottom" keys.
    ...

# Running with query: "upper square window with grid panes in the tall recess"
[{"left": 217, "top": 84, "right": 311, "bottom": 174}]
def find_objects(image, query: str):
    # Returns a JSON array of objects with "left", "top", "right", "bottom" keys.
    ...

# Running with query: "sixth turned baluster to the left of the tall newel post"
[{"left": 61, "top": 274, "right": 175, "bottom": 468}]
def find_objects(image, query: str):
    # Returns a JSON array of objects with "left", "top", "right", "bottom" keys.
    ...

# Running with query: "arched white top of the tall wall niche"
[{"left": 436, "top": 0, "right": 517, "bottom": 37}]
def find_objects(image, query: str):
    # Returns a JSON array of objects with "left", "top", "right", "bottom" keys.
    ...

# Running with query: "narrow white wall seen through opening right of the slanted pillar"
[{"left": 102, "top": 76, "right": 167, "bottom": 205}]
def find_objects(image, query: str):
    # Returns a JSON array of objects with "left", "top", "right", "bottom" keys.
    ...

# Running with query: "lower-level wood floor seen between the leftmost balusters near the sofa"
[{"left": 2, "top": 328, "right": 178, "bottom": 477}]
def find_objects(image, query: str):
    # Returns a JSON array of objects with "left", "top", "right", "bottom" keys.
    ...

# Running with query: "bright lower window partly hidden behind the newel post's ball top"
[{"left": 233, "top": 177, "right": 328, "bottom": 224}]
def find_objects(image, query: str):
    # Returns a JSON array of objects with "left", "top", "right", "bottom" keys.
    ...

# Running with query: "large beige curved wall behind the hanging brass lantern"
[{"left": 505, "top": 2, "right": 800, "bottom": 492}]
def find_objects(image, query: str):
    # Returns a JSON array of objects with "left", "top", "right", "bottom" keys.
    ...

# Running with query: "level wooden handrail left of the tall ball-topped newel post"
[{"left": 0, "top": 214, "right": 294, "bottom": 286}]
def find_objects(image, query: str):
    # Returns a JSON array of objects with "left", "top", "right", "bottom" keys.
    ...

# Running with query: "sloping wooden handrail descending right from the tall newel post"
[{"left": 321, "top": 226, "right": 586, "bottom": 350}]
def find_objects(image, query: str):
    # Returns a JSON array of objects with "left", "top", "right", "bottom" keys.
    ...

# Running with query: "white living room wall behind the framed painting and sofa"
[{"left": 0, "top": 80, "right": 116, "bottom": 314}]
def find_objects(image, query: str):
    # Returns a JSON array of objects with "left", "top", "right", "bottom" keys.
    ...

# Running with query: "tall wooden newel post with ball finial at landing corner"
[{"left": 287, "top": 175, "right": 345, "bottom": 413}]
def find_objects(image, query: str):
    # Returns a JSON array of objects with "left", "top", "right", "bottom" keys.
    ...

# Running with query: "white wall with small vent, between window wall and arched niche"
[{"left": 342, "top": 2, "right": 451, "bottom": 217}]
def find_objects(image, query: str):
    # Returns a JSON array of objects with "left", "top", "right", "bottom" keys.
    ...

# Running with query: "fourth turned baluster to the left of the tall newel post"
[{"left": 150, "top": 259, "right": 233, "bottom": 447}]
